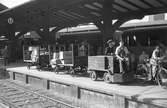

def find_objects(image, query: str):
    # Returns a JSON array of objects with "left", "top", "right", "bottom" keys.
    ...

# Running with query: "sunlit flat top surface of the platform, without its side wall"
[{"left": 7, "top": 65, "right": 167, "bottom": 107}]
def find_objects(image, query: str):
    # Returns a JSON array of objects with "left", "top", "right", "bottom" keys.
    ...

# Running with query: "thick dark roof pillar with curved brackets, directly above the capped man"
[{"left": 94, "top": 0, "right": 143, "bottom": 53}]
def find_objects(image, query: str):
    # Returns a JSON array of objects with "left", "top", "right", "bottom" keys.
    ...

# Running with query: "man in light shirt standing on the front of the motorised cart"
[{"left": 115, "top": 41, "right": 129, "bottom": 73}]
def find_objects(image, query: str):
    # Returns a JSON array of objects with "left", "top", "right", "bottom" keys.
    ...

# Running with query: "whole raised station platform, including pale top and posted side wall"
[{"left": 4, "top": 65, "right": 167, "bottom": 108}]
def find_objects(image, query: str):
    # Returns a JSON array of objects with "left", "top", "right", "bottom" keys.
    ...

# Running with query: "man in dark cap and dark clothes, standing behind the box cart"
[{"left": 105, "top": 39, "right": 115, "bottom": 55}]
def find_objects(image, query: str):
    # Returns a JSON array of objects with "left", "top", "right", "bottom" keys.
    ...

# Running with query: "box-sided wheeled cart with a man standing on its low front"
[{"left": 88, "top": 56, "right": 133, "bottom": 83}]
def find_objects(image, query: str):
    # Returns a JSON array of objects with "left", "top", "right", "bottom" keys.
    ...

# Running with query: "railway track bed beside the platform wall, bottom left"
[{"left": 0, "top": 80, "right": 79, "bottom": 108}]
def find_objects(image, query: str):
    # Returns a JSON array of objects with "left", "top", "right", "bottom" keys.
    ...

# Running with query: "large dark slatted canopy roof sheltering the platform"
[{"left": 0, "top": 0, "right": 167, "bottom": 34}]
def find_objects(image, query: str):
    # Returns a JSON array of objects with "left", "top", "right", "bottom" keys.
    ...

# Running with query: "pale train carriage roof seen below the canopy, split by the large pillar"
[{"left": 59, "top": 20, "right": 167, "bottom": 35}]
